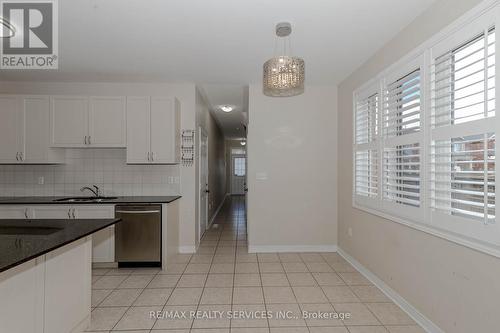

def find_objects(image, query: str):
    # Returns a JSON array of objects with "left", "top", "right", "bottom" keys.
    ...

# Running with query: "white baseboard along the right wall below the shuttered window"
[{"left": 337, "top": 248, "right": 444, "bottom": 333}]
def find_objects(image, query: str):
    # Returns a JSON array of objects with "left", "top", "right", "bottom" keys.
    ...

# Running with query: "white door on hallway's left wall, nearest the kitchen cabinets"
[{"left": 199, "top": 127, "right": 210, "bottom": 239}]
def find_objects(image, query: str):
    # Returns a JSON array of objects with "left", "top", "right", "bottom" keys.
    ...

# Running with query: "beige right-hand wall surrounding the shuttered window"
[{"left": 338, "top": 0, "right": 500, "bottom": 333}]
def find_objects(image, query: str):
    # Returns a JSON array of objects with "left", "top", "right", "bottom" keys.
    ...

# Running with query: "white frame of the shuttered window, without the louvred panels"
[{"left": 352, "top": 0, "right": 500, "bottom": 257}]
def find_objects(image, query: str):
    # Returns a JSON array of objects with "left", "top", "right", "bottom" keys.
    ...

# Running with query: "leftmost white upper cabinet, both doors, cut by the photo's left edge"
[{"left": 0, "top": 95, "right": 64, "bottom": 164}]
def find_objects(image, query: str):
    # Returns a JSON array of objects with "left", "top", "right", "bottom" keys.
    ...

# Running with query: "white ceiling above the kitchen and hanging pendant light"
[{"left": 0, "top": 0, "right": 433, "bottom": 85}]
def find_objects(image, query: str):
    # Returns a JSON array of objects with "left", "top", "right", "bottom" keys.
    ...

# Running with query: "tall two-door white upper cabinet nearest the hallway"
[{"left": 127, "top": 97, "right": 180, "bottom": 164}]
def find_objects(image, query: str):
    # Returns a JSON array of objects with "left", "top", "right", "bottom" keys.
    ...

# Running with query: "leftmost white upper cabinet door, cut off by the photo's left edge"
[{"left": 0, "top": 96, "right": 24, "bottom": 163}]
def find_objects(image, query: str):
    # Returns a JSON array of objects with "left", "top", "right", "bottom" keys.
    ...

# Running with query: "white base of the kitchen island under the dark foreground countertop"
[{"left": 0, "top": 237, "right": 92, "bottom": 333}]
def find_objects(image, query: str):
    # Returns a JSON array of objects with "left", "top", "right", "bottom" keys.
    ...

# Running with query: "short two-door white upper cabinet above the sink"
[{"left": 50, "top": 96, "right": 126, "bottom": 148}]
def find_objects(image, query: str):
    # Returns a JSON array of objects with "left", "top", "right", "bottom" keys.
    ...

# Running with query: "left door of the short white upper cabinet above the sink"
[{"left": 50, "top": 96, "right": 89, "bottom": 147}]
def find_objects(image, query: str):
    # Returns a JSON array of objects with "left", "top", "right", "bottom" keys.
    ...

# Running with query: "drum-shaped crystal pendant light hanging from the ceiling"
[{"left": 263, "top": 22, "right": 305, "bottom": 97}]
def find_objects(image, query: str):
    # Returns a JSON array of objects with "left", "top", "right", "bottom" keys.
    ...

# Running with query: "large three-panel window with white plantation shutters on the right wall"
[{"left": 353, "top": 5, "right": 500, "bottom": 257}]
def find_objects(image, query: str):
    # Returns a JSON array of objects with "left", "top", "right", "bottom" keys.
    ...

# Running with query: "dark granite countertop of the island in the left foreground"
[{"left": 0, "top": 219, "right": 120, "bottom": 272}]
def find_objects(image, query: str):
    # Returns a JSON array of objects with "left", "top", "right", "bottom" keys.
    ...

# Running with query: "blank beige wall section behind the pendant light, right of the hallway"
[{"left": 247, "top": 85, "right": 337, "bottom": 252}]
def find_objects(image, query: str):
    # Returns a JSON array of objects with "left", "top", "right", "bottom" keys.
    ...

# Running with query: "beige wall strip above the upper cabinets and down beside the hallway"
[{"left": 0, "top": 82, "right": 198, "bottom": 250}]
